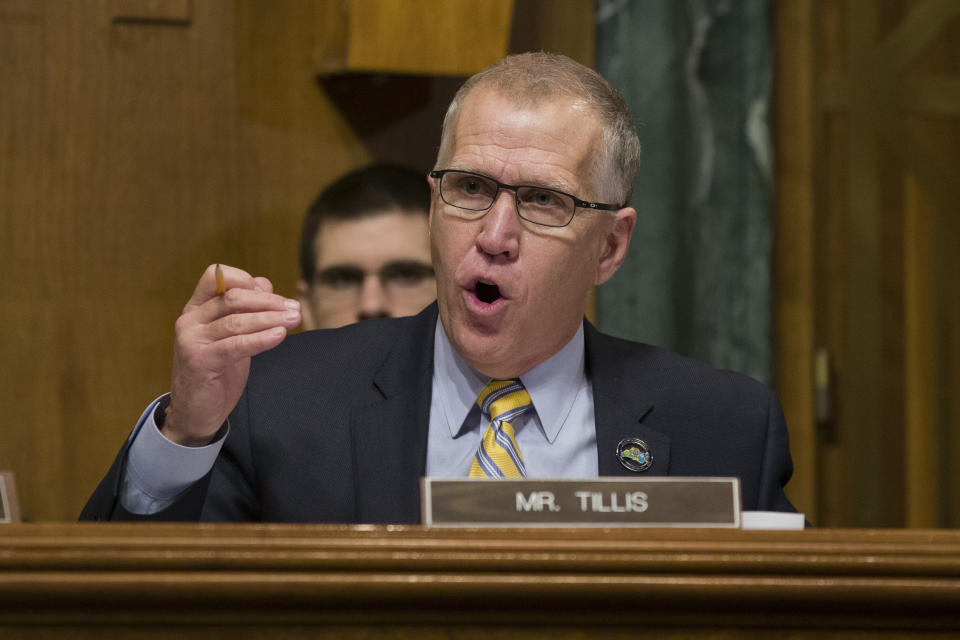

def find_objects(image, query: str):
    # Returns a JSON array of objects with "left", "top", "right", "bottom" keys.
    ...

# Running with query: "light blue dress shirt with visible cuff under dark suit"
[{"left": 120, "top": 320, "right": 598, "bottom": 514}]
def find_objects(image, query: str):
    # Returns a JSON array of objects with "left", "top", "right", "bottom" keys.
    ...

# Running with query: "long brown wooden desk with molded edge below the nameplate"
[{"left": 0, "top": 524, "right": 960, "bottom": 640}]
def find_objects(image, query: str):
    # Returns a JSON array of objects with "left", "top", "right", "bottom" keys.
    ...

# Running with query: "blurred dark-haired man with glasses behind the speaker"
[{"left": 297, "top": 165, "right": 437, "bottom": 330}]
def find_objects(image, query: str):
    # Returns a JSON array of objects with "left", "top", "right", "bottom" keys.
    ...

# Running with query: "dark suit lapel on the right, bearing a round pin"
[{"left": 584, "top": 322, "right": 670, "bottom": 477}]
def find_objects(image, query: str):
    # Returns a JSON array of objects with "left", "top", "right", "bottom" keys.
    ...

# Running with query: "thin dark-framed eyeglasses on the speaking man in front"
[{"left": 430, "top": 169, "right": 623, "bottom": 227}]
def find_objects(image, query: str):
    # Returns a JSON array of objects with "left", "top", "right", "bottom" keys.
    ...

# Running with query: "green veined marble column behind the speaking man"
[{"left": 596, "top": 0, "right": 774, "bottom": 381}]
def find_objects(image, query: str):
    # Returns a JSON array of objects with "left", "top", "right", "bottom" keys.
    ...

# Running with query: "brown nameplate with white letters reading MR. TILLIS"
[{"left": 421, "top": 478, "right": 740, "bottom": 528}]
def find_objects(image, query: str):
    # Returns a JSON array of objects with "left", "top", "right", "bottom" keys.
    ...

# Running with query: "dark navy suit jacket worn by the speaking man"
[{"left": 81, "top": 304, "right": 794, "bottom": 523}]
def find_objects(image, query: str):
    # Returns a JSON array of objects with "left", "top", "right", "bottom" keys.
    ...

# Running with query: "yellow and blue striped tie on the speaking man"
[{"left": 470, "top": 378, "right": 533, "bottom": 478}]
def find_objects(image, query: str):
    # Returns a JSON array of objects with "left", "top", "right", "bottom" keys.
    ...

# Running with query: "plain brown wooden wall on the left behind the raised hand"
[{"left": 0, "top": 0, "right": 369, "bottom": 520}]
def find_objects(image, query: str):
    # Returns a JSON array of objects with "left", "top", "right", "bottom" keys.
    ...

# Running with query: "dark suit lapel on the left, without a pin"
[{"left": 351, "top": 304, "right": 437, "bottom": 523}]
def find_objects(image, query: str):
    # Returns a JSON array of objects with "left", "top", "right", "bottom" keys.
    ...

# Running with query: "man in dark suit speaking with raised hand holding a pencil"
[{"left": 82, "top": 54, "right": 792, "bottom": 522}]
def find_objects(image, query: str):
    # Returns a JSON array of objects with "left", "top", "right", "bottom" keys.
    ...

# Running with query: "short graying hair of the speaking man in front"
[{"left": 434, "top": 52, "right": 640, "bottom": 205}]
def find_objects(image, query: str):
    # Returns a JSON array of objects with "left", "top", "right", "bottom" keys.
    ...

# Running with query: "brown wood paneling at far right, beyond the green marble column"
[{"left": 778, "top": 0, "right": 960, "bottom": 527}]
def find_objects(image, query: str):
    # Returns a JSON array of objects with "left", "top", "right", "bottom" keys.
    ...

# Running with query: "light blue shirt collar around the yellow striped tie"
[{"left": 433, "top": 318, "right": 586, "bottom": 442}]
